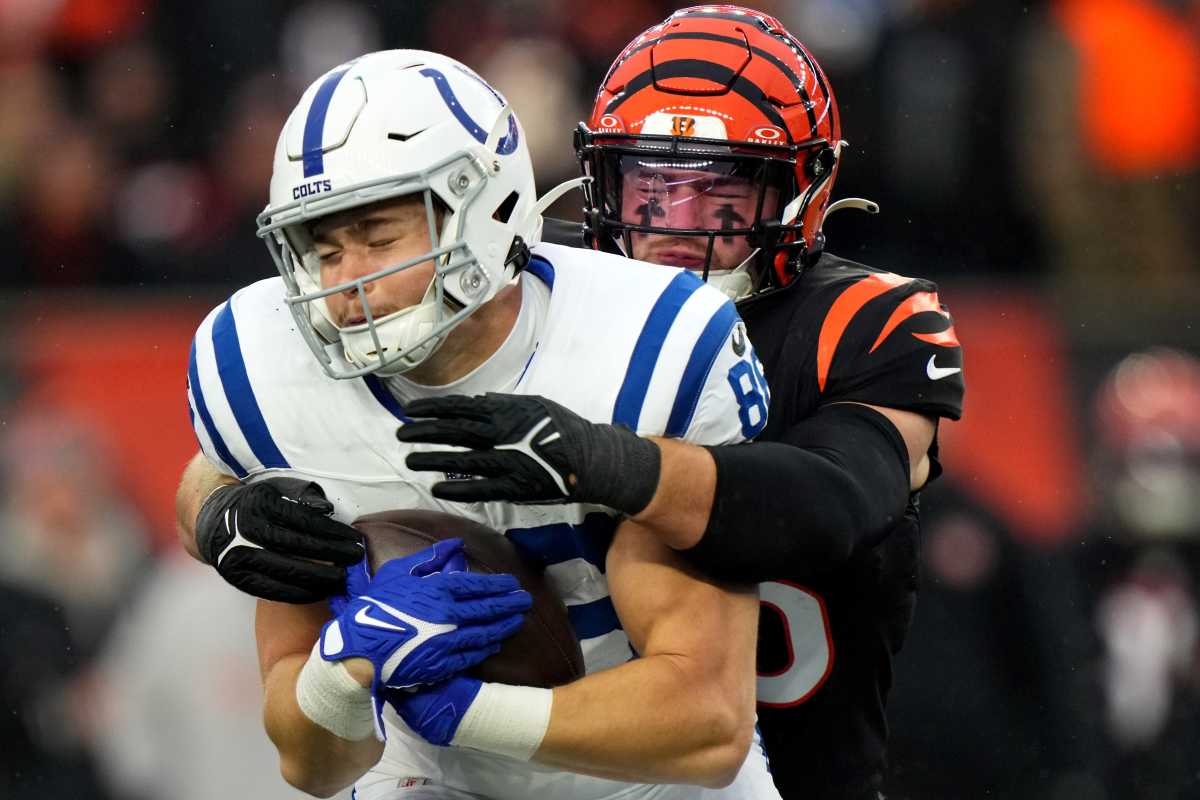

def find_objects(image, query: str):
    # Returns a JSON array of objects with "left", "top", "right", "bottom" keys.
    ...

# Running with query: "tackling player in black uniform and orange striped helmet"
[{"left": 401, "top": 5, "right": 964, "bottom": 800}]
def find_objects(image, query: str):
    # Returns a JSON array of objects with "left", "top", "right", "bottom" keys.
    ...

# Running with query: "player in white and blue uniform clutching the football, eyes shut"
[{"left": 178, "top": 50, "right": 778, "bottom": 800}]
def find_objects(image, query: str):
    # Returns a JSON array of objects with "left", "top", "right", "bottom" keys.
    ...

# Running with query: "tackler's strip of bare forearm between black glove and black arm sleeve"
[{"left": 634, "top": 437, "right": 716, "bottom": 551}]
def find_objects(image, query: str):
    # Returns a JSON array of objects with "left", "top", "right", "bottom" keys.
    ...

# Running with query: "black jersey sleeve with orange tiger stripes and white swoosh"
[{"left": 816, "top": 272, "right": 965, "bottom": 420}]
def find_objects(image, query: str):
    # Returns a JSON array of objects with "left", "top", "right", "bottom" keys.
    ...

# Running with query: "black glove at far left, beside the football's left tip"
[{"left": 196, "top": 477, "right": 365, "bottom": 603}]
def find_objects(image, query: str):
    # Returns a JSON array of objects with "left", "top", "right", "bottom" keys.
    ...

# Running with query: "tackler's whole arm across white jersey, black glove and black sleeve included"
[{"left": 396, "top": 391, "right": 936, "bottom": 583}]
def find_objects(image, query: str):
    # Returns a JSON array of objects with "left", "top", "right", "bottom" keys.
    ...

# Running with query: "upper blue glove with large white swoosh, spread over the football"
[{"left": 320, "top": 540, "right": 533, "bottom": 696}]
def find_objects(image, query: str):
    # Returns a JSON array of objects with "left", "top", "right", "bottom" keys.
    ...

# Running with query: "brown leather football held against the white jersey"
[{"left": 354, "top": 511, "right": 583, "bottom": 687}]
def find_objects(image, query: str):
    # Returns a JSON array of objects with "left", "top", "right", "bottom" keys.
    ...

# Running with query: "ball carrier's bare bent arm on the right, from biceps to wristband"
[{"left": 534, "top": 522, "right": 758, "bottom": 787}]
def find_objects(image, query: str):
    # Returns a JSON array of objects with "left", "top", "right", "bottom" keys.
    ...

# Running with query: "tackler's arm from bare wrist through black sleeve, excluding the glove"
[{"left": 634, "top": 403, "right": 936, "bottom": 581}]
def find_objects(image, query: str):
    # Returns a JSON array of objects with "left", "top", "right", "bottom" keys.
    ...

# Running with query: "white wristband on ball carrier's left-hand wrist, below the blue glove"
[{"left": 296, "top": 642, "right": 374, "bottom": 741}]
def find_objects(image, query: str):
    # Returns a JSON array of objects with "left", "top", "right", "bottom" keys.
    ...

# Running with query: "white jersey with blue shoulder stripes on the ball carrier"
[{"left": 188, "top": 245, "right": 773, "bottom": 800}]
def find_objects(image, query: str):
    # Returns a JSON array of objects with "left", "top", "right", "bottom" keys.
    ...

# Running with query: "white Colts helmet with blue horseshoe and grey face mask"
[{"left": 258, "top": 50, "right": 541, "bottom": 378}]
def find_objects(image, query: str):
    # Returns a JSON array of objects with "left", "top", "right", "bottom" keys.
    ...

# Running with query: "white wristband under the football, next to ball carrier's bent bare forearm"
[{"left": 450, "top": 684, "right": 554, "bottom": 762}]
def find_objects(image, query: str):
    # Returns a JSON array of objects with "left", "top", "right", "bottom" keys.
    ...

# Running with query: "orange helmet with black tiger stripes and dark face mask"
[{"left": 576, "top": 5, "right": 841, "bottom": 291}]
